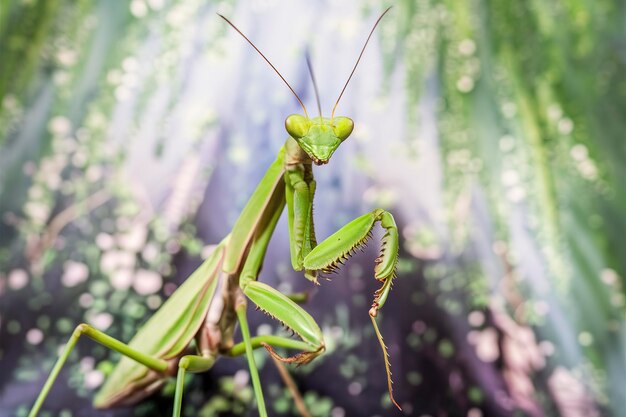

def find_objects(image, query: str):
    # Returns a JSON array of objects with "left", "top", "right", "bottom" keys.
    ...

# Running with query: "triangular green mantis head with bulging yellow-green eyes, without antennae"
[{"left": 285, "top": 114, "right": 354, "bottom": 165}]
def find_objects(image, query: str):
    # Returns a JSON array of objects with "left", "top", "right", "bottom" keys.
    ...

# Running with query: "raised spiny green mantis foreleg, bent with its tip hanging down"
[{"left": 304, "top": 209, "right": 400, "bottom": 408}]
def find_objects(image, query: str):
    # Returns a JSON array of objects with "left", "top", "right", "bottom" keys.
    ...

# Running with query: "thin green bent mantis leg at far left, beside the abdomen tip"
[{"left": 28, "top": 324, "right": 167, "bottom": 417}]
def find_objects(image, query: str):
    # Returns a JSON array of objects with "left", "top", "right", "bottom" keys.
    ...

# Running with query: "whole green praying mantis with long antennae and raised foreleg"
[{"left": 29, "top": 9, "right": 400, "bottom": 417}]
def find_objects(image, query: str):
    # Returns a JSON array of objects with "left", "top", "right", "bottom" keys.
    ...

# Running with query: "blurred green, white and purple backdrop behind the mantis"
[{"left": 0, "top": 0, "right": 626, "bottom": 417}]
